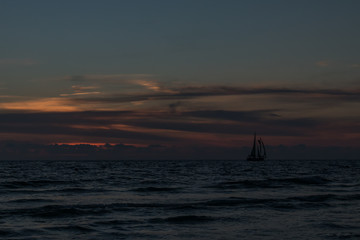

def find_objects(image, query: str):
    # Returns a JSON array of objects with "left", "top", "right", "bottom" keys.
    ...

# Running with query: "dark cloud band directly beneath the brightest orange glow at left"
[{"left": 0, "top": 111, "right": 173, "bottom": 141}]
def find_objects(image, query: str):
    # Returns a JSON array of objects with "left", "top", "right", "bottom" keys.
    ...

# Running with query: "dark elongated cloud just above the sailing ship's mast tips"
[{"left": 124, "top": 110, "right": 324, "bottom": 136}]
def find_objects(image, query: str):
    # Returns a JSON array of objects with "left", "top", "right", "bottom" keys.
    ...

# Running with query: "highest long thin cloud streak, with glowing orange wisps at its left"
[{"left": 57, "top": 73, "right": 360, "bottom": 105}]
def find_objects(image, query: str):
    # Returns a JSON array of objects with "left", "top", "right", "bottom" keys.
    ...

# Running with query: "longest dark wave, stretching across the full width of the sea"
[{"left": 4, "top": 194, "right": 360, "bottom": 218}]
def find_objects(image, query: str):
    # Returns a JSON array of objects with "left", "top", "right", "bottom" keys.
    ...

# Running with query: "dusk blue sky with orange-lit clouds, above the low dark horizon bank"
[{"left": 0, "top": 0, "right": 360, "bottom": 159}]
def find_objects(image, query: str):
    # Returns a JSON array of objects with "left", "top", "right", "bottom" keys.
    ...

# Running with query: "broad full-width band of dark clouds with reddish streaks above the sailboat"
[{"left": 0, "top": 109, "right": 360, "bottom": 146}]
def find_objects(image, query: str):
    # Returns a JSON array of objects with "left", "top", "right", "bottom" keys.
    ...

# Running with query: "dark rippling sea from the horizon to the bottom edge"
[{"left": 0, "top": 160, "right": 360, "bottom": 240}]
